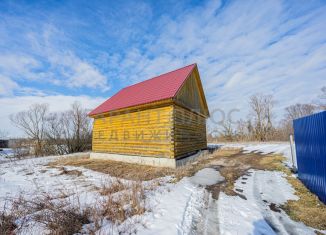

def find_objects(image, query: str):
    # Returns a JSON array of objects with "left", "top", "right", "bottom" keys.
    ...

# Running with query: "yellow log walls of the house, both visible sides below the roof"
[{"left": 93, "top": 104, "right": 207, "bottom": 158}]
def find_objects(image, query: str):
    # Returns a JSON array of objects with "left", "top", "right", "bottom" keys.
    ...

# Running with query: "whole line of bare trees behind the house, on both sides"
[{"left": 1, "top": 87, "right": 326, "bottom": 156}]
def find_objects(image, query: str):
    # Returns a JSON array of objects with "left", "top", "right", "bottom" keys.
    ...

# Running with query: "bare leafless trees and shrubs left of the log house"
[{"left": 10, "top": 102, "right": 92, "bottom": 156}]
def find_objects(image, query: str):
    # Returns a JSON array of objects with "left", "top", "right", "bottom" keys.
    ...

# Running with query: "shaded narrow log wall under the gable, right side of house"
[{"left": 173, "top": 105, "right": 207, "bottom": 158}]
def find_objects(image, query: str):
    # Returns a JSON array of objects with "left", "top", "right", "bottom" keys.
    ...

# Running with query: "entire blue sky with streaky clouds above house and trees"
[{"left": 0, "top": 0, "right": 326, "bottom": 135}]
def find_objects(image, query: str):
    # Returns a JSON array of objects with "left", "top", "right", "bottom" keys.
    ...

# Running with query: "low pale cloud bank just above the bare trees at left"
[{"left": 0, "top": 95, "right": 104, "bottom": 137}]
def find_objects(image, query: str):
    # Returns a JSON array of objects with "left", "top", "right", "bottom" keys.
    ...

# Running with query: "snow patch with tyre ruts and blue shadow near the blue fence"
[{"left": 218, "top": 170, "right": 314, "bottom": 235}]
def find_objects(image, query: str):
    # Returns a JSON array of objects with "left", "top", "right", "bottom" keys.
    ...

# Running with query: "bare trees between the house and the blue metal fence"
[{"left": 208, "top": 86, "right": 326, "bottom": 141}]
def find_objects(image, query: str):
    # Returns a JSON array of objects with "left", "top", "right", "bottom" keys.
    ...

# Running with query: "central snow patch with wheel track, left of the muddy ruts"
[{"left": 138, "top": 168, "right": 224, "bottom": 235}]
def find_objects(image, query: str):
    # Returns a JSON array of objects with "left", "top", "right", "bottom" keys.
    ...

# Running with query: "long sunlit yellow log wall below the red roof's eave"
[{"left": 93, "top": 105, "right": 174, "bottom": 157}]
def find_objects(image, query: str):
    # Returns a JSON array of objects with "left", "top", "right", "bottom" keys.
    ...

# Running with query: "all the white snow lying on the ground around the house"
[{"left": 0, "top": 143, "right": 320, "bottom": 235}]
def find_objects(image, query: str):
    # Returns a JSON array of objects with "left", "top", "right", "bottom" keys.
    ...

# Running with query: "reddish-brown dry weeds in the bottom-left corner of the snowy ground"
[{"left": 0, "top": 194, "right": 90, "bottom": 235}]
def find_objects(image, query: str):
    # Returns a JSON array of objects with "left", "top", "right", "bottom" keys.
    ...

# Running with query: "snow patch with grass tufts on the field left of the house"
[{"left": 0, "top": 153, "right": 129, "bottom": 234}]
